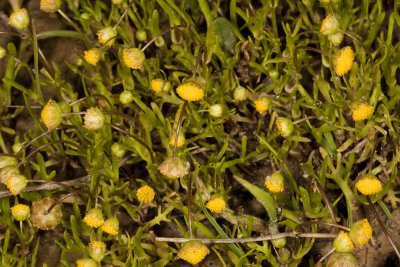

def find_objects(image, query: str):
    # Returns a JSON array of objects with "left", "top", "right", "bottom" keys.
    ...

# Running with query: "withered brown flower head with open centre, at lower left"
[{"left": 30, "top": 197, "right": 62, "bottom": 230}]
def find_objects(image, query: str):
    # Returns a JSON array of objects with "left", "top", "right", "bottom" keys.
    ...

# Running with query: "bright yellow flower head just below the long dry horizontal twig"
[{"left": 178, "top": 240, "right": 210, "bottom": 264}]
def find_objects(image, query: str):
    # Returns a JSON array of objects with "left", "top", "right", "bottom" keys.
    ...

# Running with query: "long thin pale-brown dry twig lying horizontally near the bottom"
[{"left": 155, "top": 232, "right": 337, "bottom": 244}]
